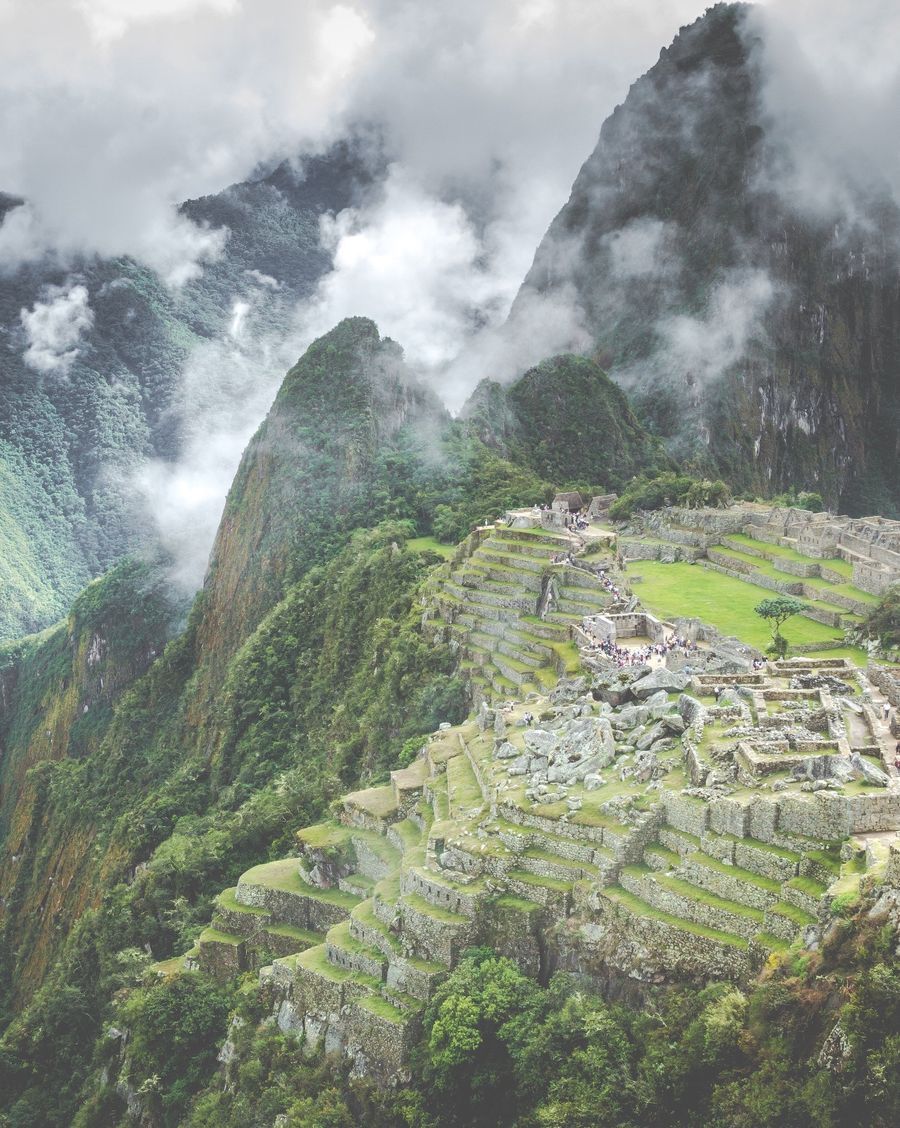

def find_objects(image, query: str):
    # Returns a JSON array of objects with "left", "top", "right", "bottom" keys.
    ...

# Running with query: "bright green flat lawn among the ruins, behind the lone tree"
[{"left": 632, "top": 561, "right": 866, "bottom": 666}]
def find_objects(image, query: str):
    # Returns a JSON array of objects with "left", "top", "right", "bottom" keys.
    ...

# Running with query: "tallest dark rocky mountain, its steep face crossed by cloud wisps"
[{"left": 511, "top": 5, "right": 900, "bottom": 512}]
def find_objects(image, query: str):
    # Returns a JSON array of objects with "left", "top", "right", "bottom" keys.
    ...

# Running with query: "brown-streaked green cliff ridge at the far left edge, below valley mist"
[{"left": 0, "top": 563, "right": 178, "bottom": 992}]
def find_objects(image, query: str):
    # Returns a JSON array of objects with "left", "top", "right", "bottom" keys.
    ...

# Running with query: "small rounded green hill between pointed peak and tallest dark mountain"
[{"left": 462, "top": 354, "right": 665, "bottom": 490}]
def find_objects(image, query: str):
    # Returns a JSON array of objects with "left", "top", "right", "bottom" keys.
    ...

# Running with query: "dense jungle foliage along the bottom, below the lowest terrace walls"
[{"left": 61, "top": 914, "right": 900, "bottom": 1128}]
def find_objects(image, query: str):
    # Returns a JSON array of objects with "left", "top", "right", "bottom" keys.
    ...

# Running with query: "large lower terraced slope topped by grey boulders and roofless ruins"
[{"left": 174, "top": 661, "right": 900, "bottom": 1083}]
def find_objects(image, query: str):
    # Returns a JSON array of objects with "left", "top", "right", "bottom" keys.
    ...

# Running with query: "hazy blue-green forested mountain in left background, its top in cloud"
[{"left": 0, "top": 144, "right": 370, "bottom": 637}]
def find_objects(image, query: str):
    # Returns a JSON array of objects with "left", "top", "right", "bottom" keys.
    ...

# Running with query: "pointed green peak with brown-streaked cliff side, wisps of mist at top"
[{"left": 197, "top": 317, "right": 448, "bottom": 697}]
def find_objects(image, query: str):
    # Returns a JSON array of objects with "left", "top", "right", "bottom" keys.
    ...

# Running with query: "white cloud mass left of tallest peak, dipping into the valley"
[{"left": 0, "top": 0, "right": 766, "bottom": 583}]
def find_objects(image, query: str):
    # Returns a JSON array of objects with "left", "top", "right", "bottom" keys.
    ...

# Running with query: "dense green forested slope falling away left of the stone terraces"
[{"left": 0, "top": 525, "right": 468, "bottom": 1126}]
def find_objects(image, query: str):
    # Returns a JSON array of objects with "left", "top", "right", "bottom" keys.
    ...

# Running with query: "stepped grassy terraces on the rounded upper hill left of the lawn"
[{"left": 430, "top": 527, "right": 615, "bottom": 700}]
